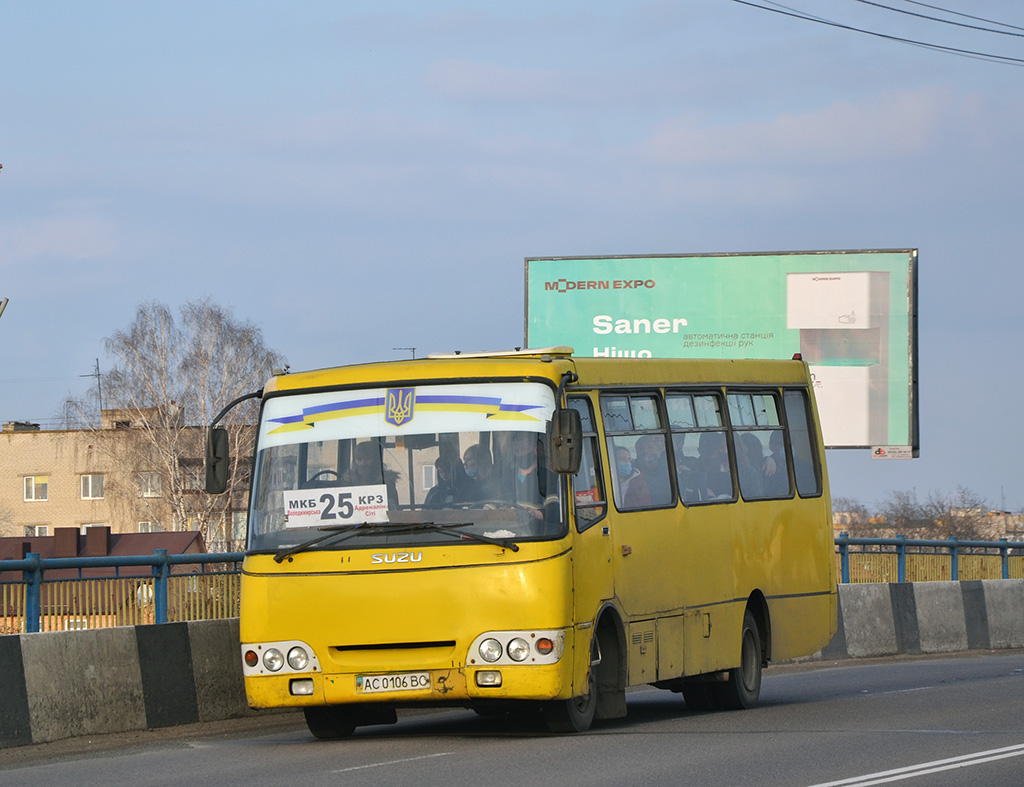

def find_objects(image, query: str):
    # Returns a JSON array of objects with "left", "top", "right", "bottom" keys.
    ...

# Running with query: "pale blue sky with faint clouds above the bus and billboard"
[{"left": 0, "top": 0, "right": 1024, "bottom": 512}]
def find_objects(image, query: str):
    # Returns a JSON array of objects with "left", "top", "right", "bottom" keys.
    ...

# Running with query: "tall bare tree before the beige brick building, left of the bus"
[{"left": 66, "top": 300, "right": 284, "bottom": 544}]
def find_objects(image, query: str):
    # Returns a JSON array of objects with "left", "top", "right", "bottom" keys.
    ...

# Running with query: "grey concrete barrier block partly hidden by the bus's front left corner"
[{"left": 188, "top": 617, "right": 251, "bottom": 722}]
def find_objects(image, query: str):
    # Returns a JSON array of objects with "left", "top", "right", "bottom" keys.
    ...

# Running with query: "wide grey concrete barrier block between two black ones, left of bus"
[{"left": 22, "top": 627, "right": 145, "bottom": 743}]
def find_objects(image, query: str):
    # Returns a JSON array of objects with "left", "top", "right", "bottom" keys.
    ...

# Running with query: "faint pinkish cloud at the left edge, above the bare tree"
[{"left": 0, "top": 211, "right": 118, "bottom": 265}]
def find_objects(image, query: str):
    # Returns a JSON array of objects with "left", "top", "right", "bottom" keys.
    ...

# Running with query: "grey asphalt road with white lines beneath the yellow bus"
[{"left": 0, "top": 651, "right": 1024, "bottom": 787}]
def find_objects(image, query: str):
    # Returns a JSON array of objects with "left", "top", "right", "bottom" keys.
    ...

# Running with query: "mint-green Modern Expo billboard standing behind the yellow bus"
[{"left": 525, "top": 249, "right": 920, "bottom": 456}]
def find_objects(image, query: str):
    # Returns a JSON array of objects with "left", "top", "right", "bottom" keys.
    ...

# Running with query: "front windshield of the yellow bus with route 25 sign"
[{"left": 249, "top": 383, "right": 565, "bottom": 555}]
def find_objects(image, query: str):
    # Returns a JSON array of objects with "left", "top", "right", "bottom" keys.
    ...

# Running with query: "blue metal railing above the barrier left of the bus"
[{"left": 0, "top": 550, "right": 245, "bottom": 633}]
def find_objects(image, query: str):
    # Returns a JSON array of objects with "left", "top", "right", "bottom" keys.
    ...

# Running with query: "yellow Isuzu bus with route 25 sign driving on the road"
[{"left": 207, "top": 347, "right": 837, "bottom": 738}]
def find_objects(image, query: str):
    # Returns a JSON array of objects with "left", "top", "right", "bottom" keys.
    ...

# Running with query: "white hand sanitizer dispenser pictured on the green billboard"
[{"left": 785, "top": 271, "right": 889, "bottom": 446}]
